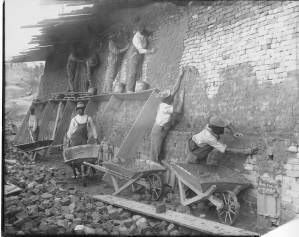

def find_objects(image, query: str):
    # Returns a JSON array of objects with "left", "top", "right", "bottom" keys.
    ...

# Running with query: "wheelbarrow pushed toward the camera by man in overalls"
[{"left": 62, "top": 144, "right": 101, "bottom": 186}]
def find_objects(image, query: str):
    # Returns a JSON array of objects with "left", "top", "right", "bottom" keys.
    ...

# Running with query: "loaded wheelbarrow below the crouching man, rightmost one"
[{"left": 165, "top": 163, "right": 251, "bottom": 225}]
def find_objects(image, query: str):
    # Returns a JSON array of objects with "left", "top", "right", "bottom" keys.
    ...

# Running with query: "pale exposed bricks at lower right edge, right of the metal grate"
[{"left": 281, "top": 152, "right": 299, "bottom": 215}]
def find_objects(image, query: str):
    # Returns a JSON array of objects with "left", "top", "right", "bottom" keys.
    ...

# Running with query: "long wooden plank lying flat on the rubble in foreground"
[{"left": 92, "top": 195, "right": 258, "bottom": 236}]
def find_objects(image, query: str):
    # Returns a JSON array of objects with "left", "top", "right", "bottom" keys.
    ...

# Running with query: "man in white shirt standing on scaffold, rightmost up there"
[{"left": 127, "top": 25, "right": 154, "bottom": 92}]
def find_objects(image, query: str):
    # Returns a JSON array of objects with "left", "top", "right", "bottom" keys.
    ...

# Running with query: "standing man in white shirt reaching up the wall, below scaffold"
[{"left": 150, "top": 66, "right": 189, "bottom": 162}]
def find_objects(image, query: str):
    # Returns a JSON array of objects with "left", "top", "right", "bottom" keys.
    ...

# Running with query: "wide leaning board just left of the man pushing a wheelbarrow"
[{"left": 53, "top": 101, "right": 76, "bottom": 145}]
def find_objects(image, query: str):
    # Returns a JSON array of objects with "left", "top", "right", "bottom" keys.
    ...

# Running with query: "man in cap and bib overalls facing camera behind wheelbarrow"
[{"left": 67, "top": 101, "right": 98, "bottom": 178}]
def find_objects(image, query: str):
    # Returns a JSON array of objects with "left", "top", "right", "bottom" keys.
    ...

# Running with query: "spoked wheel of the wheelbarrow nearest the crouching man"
[{"left": 217, "top": 191, "right": 240, "bottom": 225}]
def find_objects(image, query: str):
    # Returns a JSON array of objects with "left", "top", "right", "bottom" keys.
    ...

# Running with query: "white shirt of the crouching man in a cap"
[{"left": 192, "top": 125, "right": 227, "bottom": 153}]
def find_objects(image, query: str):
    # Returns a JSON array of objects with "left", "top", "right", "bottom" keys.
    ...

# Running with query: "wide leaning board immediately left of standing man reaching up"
[{"left": 116, "top": 92, "right": 161, "bottom": 159}]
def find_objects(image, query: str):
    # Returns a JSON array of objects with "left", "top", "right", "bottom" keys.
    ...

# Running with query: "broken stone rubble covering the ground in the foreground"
[{"left": 4, "top": 130, "right": 256, "bottom": 235}]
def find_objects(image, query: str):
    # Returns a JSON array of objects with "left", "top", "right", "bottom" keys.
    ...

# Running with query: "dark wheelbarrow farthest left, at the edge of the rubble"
[{"left": 14, "top": 140, "right": 53, "bottom": 161}]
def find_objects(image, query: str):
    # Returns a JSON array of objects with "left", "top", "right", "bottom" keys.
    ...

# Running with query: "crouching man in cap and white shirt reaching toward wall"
[{"left": 187, "top": 115, "right": 257, "bottom": 165}]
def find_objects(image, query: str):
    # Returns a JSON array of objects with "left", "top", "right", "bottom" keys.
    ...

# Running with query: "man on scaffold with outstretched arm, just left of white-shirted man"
[{"left": 104, "top": 31, "right": 129, "bottom": 93}]
